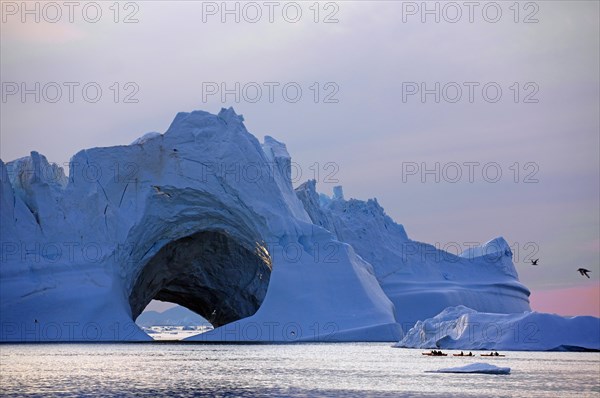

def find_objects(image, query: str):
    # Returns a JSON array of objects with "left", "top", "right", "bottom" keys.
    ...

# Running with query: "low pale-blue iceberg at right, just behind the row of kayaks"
[{"left": 395, "top": 306, "right": 600, "bottom": 351}]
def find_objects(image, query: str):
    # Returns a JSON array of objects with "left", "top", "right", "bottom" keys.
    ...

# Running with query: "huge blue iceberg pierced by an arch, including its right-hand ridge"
[{"left": 0, "top": 108, "right": 529, "bottom": 341}]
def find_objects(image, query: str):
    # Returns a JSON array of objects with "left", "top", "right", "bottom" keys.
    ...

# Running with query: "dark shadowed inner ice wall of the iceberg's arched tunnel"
[{"left": 129, "top": 231, "right": 271, "bottom": 327}]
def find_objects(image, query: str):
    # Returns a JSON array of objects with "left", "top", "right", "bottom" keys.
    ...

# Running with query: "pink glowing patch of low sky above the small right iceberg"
[{"left": 529, "top": 284, "right": 600, "bottom": 317}]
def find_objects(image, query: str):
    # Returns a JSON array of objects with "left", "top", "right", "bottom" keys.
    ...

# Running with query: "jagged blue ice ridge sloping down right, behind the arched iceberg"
[{"left": 296, "top": 180, "right": 531, "bottom": 332}]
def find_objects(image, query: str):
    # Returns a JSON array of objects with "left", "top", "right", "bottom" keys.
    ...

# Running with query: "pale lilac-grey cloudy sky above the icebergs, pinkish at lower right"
[{"left": 0, "top": 1, "right": 600, "bottom": 316}]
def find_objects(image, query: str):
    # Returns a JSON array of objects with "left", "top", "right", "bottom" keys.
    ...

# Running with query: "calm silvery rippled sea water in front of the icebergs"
[{"left": 0, "top": 343, "right": 600, "bottom": 398}]
